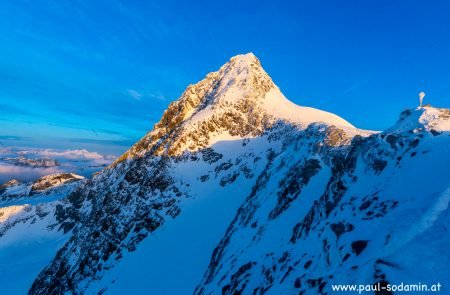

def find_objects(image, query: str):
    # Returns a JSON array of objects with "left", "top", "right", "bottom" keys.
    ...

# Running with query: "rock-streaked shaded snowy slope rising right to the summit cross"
[{"left": 196, "top": 108, "right": 450, "bottom": 294}]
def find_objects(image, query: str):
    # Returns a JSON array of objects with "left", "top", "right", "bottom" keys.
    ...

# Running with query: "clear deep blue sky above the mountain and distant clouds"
[{"left": 0, "top": 0, "right": 450, "bottom": 154}]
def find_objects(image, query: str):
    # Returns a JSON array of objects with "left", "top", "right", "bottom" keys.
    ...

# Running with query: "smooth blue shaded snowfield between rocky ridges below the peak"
[{"left": 87, "top": 139, "right": 276, "bottom": 294}]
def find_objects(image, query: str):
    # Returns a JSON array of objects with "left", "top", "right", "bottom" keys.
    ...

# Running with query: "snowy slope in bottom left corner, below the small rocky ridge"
[{"left": 0, "top": 202, "right": 69, "bottom": 295}]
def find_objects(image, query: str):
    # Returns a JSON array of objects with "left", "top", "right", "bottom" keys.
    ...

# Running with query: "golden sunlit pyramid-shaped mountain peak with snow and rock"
[{"left": 117, "top": 53, "right": 354, "bottom": 162}]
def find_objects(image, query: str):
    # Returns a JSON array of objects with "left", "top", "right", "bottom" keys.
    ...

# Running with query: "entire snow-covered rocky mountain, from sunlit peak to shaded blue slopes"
[{"left": 0, "top": 54, "right": 450, "bottom": 294}]
